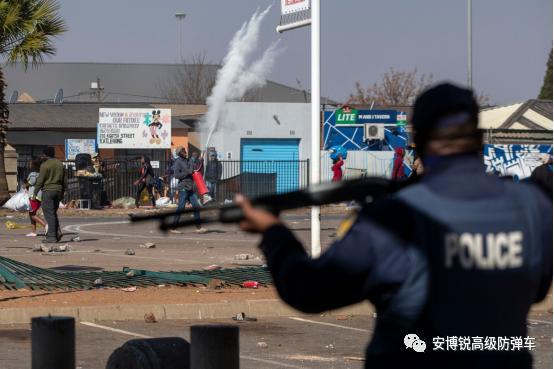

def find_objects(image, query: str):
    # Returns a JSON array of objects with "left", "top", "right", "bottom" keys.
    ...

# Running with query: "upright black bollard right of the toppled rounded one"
[{"left": 190, "top": 325, "right": 239, "bottom": 369}]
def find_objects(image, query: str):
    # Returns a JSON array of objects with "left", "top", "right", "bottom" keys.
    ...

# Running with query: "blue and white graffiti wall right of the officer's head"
[{"left": 484, "top": 145, "right": 552, "bottom": 180}]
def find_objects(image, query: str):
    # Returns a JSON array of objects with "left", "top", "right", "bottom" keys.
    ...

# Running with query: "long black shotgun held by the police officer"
[{"left": 129, "top": 177, "right": 413, "bottom": 231}]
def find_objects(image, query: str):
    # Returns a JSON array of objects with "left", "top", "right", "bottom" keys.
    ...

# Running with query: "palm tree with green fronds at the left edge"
[{"left": 0, "top": 0, "right": 67, "bottom": 205}]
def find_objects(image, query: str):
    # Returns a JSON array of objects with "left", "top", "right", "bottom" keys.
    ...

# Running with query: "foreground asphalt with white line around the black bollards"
[{"left": 0, "top": 313, "right": 552, "bottom": 369}]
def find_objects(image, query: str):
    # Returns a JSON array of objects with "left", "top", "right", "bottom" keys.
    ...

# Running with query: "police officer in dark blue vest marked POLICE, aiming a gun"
[{"left": 237, "top": 84, "right": 552, "bottom": 369}]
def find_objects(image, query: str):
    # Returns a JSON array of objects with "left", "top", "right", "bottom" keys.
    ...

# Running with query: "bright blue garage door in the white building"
[{"left": 240, "top": 138, "right": 300, "bottom": 193}]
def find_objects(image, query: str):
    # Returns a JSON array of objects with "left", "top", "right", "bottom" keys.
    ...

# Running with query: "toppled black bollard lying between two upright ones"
[{"left": 106, "top": 337, "right": 190, "bottom": 369}]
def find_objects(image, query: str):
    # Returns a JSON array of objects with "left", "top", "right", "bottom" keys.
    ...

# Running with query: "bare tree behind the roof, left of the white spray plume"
[{"left": 162, "top": 53, "right": 217, "bottom": 104}]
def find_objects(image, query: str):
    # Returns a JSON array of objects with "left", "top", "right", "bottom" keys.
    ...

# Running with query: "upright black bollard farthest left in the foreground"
[{"left": 31, "top": 316, "right": 75, "bottom": 369}]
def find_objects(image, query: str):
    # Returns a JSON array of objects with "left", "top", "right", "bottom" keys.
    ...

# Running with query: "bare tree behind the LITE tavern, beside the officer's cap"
[{"left": 349, "top": 68, "right": 433, "bottom": 106}]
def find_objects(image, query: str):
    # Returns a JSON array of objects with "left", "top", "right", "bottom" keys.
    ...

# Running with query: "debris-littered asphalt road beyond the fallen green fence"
[{"left": 0, "top": 215, "right": 342, "bottom": 270}]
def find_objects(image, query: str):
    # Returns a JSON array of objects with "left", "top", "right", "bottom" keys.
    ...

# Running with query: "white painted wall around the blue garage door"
[{"left": 210, "top": 102, "right": 311, "bottom": 160}]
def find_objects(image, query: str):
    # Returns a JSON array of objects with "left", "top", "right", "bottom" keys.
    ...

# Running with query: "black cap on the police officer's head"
[{"left": 412, "top": 83, "right": 479, "bottom": 149}]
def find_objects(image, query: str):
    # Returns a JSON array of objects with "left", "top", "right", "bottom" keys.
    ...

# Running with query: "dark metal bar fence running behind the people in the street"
[{"left": 17, "top": 160, "right": 309, "bottom": 203}]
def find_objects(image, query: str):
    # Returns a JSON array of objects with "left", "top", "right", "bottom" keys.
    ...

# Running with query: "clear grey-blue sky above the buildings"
[{"left": 45, "top": 0, "right": 553, "bottom": 104}]
